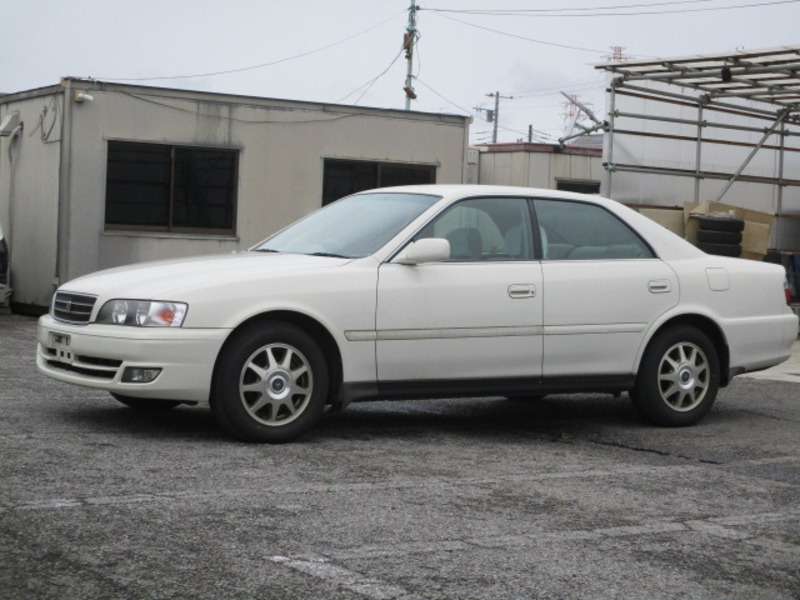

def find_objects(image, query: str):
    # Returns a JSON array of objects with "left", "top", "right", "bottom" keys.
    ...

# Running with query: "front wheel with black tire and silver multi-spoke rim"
[{"left": 211, "top": 322, "right": 329, "bottom": 443}]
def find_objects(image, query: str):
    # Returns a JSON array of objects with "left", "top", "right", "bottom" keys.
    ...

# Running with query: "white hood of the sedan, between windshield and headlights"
[{"left": 61, "top": 252, "right": 351, "bottom": 301}]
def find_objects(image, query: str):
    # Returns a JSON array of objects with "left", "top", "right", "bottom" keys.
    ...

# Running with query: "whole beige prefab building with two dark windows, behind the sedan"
[{"left": 0, "top": 79, "right": 469, "bottom": 308}]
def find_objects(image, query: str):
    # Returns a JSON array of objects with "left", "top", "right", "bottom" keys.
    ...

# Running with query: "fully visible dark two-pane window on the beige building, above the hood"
[{"left": 106, "top": 142, "right": 238, "bottom": 233}]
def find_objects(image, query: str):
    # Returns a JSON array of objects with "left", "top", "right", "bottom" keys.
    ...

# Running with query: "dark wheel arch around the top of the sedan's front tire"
[{"left": 211, "top": 310, "right": 342, "bottom": 402}]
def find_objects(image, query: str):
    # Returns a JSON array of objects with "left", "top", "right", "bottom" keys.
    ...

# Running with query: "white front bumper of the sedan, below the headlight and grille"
[{"left": 36, "top": 315, "right": 230, "bottom": 403}]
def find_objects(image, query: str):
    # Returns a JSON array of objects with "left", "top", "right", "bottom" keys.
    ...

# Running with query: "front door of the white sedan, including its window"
[{"left": 376, "top": 197, "right": 542, "bottom": 384}]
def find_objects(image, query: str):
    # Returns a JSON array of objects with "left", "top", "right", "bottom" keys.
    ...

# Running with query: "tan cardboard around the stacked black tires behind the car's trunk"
[{"left": 683, "top": 202, "right": 775, "bottom": 260}]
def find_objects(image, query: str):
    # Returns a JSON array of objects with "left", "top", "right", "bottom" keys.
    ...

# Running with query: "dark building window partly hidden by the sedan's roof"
[{"left": 322, "top": 158, "right": 436, "bottom": 206}]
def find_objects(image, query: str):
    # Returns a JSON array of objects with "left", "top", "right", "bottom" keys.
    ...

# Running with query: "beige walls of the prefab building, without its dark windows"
[{"left": 0, "top": 80, "right": 468, "bottom": 305}]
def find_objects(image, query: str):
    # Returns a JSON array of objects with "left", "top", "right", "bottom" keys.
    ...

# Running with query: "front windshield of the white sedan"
[{"left": 253, "top": 192, "right": 439, "bottom": 258}]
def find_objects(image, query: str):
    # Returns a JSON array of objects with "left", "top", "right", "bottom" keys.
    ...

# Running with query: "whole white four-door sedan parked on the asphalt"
[{"left": 37, "top": 185, "right": 798, "bottom": 442}]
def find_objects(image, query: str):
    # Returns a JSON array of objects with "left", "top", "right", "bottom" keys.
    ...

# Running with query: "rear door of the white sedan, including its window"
[{"left": 534, "top": 199, "right": 679, "bottom": 378}]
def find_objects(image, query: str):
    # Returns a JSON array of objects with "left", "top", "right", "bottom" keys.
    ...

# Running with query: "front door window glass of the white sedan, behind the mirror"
[{"left": 414, "top": 198, "right": 533, "bottom": 262}]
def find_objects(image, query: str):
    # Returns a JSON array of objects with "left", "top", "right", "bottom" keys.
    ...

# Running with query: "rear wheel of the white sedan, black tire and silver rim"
[{"left": 631, "top": 325, "right": 720, "bottom": 427}]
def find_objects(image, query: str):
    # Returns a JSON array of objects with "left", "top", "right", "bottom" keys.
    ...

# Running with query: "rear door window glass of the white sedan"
[{"left": 534, "top": 200, "right": 653, "bottom": 260}]
